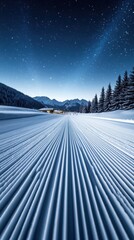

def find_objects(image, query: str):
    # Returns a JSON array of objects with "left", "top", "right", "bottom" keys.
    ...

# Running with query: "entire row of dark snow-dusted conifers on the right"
[{"left": 86, "top": 67, "right": 134, "bottom": 113}]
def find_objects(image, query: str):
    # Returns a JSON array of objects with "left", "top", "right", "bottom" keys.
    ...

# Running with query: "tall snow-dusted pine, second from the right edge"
[{"left": 120, "top": 71, "right": 129, "bottom": 109}]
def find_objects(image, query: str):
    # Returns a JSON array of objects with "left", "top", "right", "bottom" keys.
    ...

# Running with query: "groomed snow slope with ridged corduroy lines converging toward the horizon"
[{"left": 0, "top": 109, "right": 134, "bottom": 240}]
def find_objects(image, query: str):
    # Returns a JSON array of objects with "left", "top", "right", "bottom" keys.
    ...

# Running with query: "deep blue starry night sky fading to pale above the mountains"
[{"left": 0, "top": 0, "right": 134, "bottom": 100}]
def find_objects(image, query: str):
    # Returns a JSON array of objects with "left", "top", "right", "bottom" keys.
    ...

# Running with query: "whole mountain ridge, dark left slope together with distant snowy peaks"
[{"left": 0, "top": 82, "right": 88, "bottom": 112}]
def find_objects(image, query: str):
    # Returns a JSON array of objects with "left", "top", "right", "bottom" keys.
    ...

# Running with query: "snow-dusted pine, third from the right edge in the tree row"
[{"left": 111, "top": 75, "right": 122, "bottom": 110}]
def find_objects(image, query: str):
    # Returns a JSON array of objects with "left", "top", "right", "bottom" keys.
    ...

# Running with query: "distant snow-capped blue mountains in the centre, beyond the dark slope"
[{"left": 34, "top": 96, "right": 88, "bottom": 112}]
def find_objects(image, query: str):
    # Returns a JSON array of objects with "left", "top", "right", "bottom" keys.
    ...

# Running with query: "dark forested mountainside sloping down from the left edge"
[{"left": 0, "top": 83, "right": 44, "bottom": 109}]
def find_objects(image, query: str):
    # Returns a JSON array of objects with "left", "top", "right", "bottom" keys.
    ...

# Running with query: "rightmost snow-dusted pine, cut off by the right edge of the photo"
[{"left": 123, "top": 67, "right": 134, "bottom": 109}]
